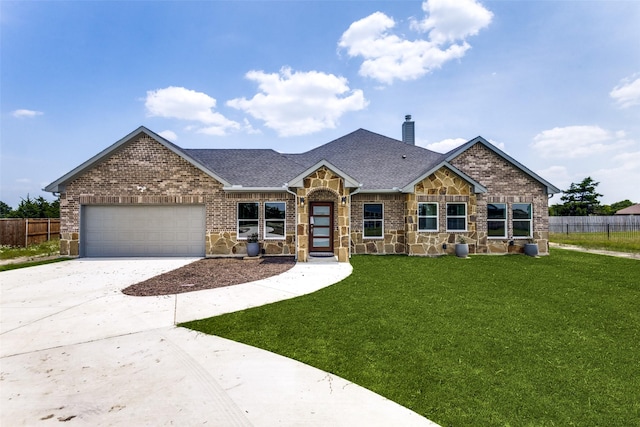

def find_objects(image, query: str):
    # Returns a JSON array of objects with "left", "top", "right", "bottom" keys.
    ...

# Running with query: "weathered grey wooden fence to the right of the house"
[{"left": 549, "top": 215, "right": 640, "bottom": 239}]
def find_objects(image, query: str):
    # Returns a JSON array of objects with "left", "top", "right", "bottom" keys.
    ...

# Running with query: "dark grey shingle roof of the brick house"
[{"left": 45, "top": 126, "right": 560, "bottom": 193}]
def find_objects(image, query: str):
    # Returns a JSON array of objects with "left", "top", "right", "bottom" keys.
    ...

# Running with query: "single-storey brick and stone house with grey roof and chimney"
[{"left": 45, "top": 116, "right": 560, "bottom": 262}]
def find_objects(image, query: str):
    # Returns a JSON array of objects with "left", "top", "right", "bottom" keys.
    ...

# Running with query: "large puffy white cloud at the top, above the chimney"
[{"left": 338, "top": 0, "right": 493, "bottom": 84}]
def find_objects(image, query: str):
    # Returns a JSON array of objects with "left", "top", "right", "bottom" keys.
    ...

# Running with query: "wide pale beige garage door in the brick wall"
[{"left": 80, "top": 205, "right": 205, "bottom": 257}]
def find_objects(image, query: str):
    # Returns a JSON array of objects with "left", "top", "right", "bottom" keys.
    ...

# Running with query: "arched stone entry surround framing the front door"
[{"left": 297, "top": 166, "right": 349, "bottom": 262}]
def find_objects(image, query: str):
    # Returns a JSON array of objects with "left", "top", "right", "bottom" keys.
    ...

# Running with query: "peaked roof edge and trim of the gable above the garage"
[{"left": 44, "top": 126, "right": 229, "bottom": 193}]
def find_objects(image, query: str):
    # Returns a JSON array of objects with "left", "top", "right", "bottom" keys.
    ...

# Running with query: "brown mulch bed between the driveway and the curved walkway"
[{"left": 122, "top": 257, "right": 296, "bottom": 297}]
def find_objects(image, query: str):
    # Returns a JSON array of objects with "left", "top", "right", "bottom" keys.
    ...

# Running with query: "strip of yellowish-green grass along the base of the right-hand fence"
[{"left": 549, "top": 232, "right": 640, "bottom": 253}]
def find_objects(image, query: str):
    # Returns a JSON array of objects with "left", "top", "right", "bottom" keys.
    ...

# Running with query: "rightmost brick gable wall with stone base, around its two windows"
[{"left": 450, "top": 143, "right": 549, "bottom": 254}]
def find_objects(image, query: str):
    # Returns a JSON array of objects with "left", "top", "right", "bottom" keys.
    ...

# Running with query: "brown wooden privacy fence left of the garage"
[{"left": 0, "top": 218, "right": 60, "bottom": 247}]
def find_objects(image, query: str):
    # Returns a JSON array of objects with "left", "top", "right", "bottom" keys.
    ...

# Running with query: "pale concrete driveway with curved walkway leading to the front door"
[{"left": 0, "top": 258, "right": 436, "bottom": 426}]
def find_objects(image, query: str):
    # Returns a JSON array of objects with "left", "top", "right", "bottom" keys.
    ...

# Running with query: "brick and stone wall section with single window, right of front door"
[{"left": 351, "top": 193, "right": 406, "bottom": 254}]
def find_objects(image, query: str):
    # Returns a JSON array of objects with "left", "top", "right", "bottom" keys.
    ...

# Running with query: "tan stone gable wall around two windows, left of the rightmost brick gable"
[{"left": 405, "top": 167, "right": 478, "bottom": 256}]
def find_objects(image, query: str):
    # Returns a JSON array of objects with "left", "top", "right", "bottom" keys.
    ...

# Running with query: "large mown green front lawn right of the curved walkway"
[{"left": 183, "top": 250, "right": 640, "bottom": 426}]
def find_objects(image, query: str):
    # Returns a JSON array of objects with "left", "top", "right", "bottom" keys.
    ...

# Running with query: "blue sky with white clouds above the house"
[{"left": 0, "top": 0, "right": 640, "bottom": 207}]
